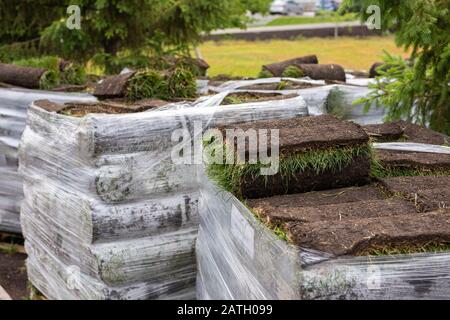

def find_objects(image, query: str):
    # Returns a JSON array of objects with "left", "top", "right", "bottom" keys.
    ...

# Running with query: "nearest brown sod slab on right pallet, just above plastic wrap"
[{"left": 287, "top": 212, "right": 450, "bottom": 255}]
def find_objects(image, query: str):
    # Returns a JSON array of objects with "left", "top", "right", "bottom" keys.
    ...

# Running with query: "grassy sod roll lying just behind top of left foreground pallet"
[{"left": 94, "top": 68, "right": 196, "bottom": 100}]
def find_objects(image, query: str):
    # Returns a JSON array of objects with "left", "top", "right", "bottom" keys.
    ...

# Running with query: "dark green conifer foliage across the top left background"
[{"left": 0, "top": 0, "right": 258, "bottom": 72}]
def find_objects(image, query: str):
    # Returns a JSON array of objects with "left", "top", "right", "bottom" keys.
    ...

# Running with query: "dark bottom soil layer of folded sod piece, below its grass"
[{"left": 240, "top": 156, "right": 370, "bottom": 199}]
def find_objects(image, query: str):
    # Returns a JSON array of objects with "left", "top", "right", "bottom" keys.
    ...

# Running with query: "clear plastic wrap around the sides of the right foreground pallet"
[{"left": 196, "top": 173, "right": 450, "bottom": 299}]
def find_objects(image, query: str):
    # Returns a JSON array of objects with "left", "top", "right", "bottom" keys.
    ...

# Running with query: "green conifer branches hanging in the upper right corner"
[{"left": 342, "top": 0, "right": 450, "bottom": 135}]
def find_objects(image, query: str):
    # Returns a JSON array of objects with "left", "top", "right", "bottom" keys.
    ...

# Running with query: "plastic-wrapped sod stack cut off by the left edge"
[{"left": 0, "top": 89, "right": 95, "bottom": 233}]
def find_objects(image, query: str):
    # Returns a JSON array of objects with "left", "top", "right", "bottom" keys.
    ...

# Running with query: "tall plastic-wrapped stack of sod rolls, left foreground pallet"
[{"left": 20, "top": 91, "right": 307, "bottom": 299}]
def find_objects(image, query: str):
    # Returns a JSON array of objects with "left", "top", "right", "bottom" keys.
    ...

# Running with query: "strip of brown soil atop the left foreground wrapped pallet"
[{"left": 35, "top": 99, "right": 167, "bottom": 117}]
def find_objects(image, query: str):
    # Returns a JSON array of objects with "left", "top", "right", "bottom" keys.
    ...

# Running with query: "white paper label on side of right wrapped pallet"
[{"left": 230, "top": 205, "right": 255, "bottom": 259}]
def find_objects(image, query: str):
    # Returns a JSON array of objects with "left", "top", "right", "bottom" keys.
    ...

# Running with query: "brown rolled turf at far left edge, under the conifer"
[{"left": 0, "top": 63, "right": 57, "bottom": 89}]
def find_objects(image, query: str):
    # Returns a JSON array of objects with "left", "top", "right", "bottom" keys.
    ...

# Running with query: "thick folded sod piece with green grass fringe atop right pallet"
[{"left": 204, "top": 115, "right": 372, "bottom": 199}]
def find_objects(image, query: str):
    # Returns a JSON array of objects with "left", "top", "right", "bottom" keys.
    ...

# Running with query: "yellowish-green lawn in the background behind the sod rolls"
[{"left": 200, "top": 36, "right": 408, "bottom": 77}]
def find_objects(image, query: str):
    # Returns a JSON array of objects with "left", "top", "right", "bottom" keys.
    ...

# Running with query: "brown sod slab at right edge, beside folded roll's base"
[{"left": 378, "top": 176, "right": 450, "bottom": 195}]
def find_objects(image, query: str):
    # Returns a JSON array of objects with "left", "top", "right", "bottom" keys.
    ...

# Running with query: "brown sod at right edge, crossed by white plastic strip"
[{"left": 363, "top": 121, "right": 450, "bottom": 177}]
